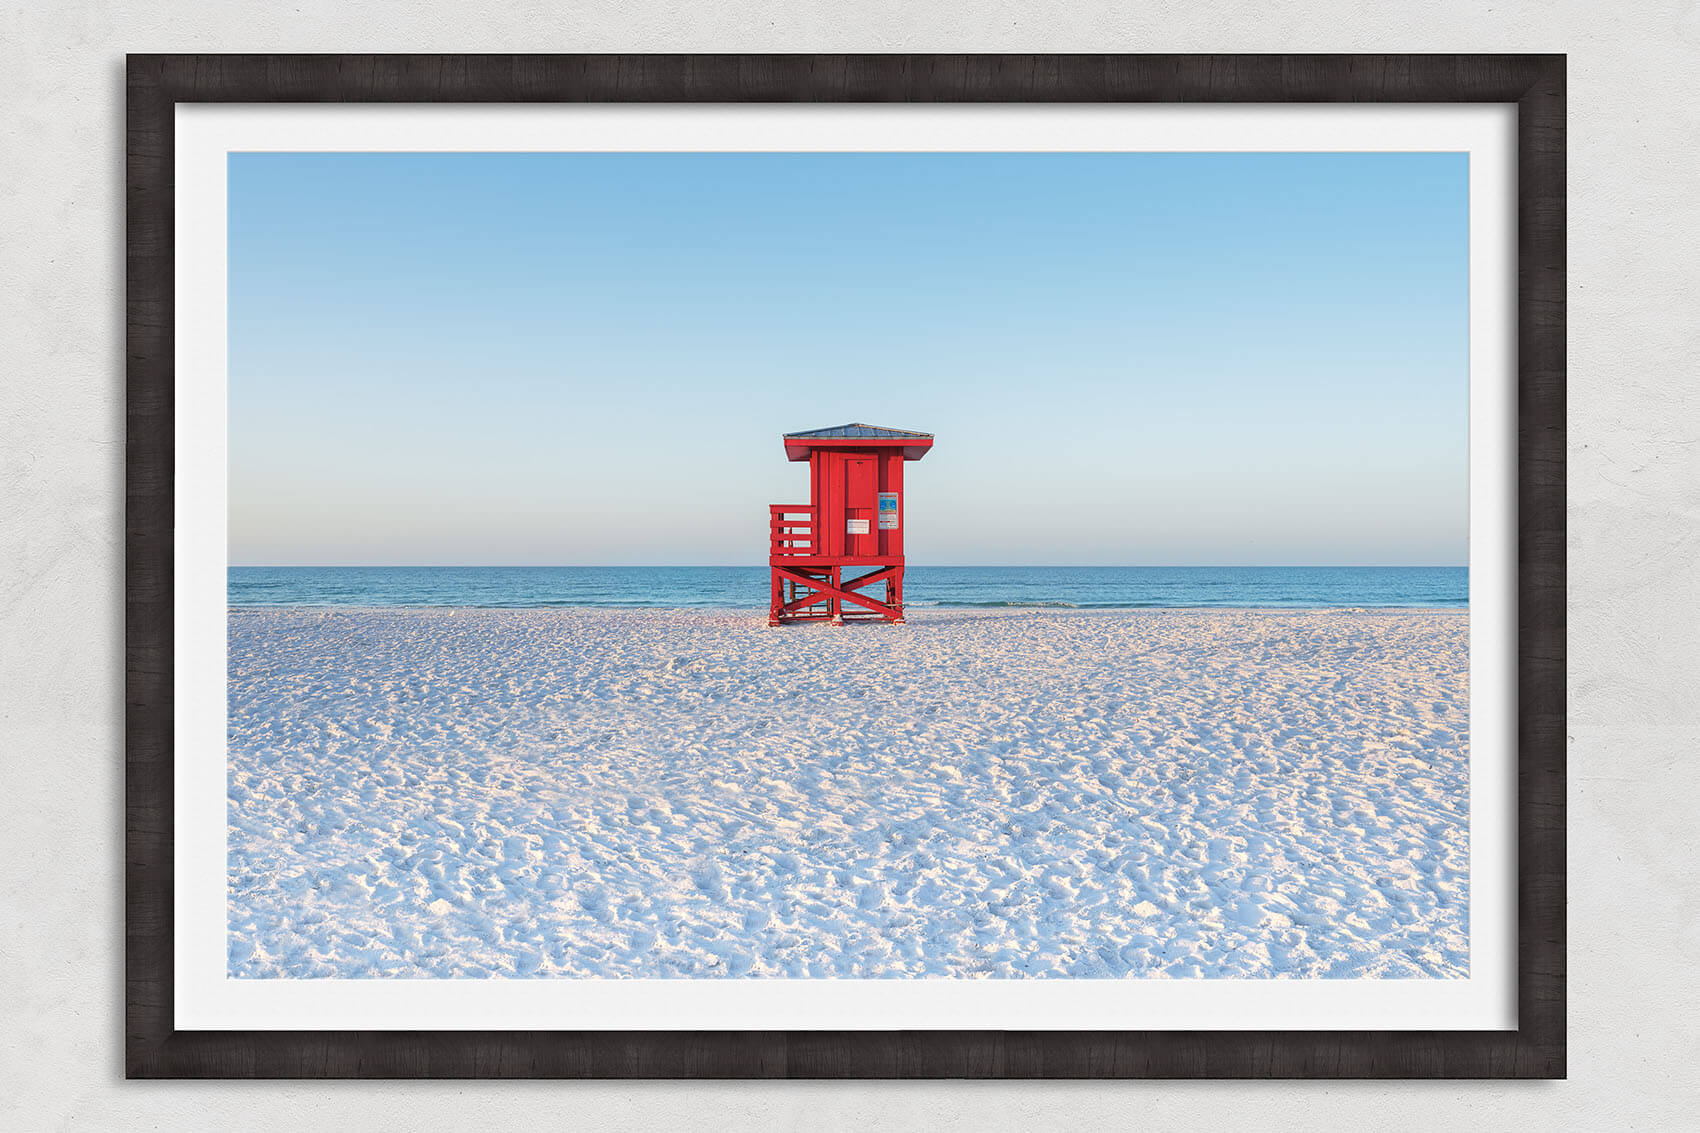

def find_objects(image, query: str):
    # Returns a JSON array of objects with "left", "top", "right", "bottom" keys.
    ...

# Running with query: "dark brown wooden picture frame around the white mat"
[{"left": 124, "top": 54, "right": 1566, "bottom": 1079}]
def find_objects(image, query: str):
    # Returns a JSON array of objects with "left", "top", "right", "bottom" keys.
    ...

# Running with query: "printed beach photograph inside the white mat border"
[{"left": 224, "top": 151, "right": 1471, "bottom": 982}]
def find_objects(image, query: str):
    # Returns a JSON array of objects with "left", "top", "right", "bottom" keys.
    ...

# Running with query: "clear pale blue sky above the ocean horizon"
[{"left": 230, "top": 153, "right": 1469, "bottom": 565}]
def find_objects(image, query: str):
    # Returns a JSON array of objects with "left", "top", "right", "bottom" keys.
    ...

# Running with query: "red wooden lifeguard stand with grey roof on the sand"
[{"left": 767, "top": 424, "right": 933, "bottom": 626}]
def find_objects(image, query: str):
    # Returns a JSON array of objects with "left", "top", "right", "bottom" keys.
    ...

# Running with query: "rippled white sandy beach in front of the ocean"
[{"left": 230, "top": 609, "right": 1469, "bottom": 978}]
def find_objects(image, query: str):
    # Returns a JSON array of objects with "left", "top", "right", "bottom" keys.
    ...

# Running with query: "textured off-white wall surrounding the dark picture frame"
[{"left": 0, "top": 0, "right": 1700, "bottom": 1130}]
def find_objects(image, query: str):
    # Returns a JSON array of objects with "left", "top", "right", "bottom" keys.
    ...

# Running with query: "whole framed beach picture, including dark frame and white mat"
[{"left": 126, "top": 54, "right": 1564, "bottom": 1077}]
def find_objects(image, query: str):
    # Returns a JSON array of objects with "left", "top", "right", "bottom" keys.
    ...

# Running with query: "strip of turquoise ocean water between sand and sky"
[{"left": 230, "top": 567, "right": 1469, "bottom": 609}]
